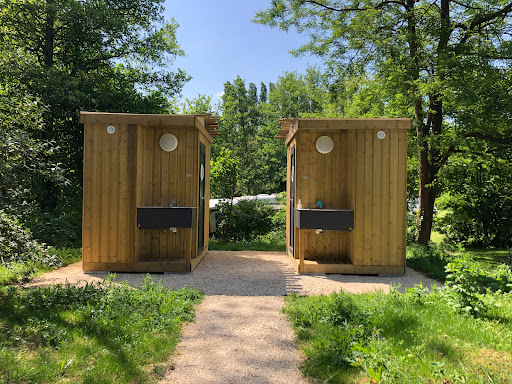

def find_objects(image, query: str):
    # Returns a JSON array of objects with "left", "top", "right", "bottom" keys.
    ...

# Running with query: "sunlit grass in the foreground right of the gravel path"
[{"left": 285, "top": 288, "right": 512, "bottom": 384}]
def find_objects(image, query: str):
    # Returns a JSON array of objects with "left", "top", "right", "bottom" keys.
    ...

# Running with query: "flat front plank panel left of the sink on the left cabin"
[{"left": 82, "top": 124, "right": 136, "bottom": 269}]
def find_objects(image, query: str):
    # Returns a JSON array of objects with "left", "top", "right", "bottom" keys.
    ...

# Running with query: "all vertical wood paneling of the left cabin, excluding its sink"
[{"left": 82, "top": 115, "right": 214, "bottom": 270}]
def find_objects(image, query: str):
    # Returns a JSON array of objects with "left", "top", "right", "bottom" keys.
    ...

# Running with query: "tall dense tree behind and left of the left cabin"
[{"left": 0, "top": 0, "right": 189, "bottom": 246}]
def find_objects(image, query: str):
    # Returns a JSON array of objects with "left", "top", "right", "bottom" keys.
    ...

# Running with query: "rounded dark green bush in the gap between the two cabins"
[{"left": 217, "top": 199, "right": 274, "bottom": 241}]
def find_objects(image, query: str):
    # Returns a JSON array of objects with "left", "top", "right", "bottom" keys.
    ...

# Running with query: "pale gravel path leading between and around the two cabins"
[{"left": 29, "top": 251, "right": 440, "bottom": 384}]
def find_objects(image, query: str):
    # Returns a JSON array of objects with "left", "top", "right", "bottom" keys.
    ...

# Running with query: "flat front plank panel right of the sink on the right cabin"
[{"left": 352, "top": 129, "right": 407, "bottom": 266}]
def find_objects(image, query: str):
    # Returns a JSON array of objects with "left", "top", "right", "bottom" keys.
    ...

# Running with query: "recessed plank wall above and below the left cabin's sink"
[{"left": 135, "top": 126, "right": 198, "bottom": 262}]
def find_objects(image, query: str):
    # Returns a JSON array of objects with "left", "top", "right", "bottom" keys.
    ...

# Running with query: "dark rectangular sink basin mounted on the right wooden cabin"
[{"left": 295, "top": 209, "right": 354, "bottom": 231}]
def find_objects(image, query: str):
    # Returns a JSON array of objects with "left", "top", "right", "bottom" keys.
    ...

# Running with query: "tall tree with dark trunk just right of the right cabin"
[{"left": 255, "top": 0, "right": 512, "bottom": 245}]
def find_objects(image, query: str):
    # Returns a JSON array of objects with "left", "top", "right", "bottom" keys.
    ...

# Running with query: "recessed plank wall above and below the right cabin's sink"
[{"left": 288, "top": 130, "right": 355, "bottom": 264}]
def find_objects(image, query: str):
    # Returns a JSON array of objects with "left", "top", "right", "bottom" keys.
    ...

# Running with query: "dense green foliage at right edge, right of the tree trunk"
[{"left": 438, "top": 150, "right": 512, "bottom": 247}]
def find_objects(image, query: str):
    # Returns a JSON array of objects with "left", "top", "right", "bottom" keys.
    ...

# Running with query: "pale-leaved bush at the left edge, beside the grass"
[{"left": 0, "top": 211, "right": 62, "bottom": 279}]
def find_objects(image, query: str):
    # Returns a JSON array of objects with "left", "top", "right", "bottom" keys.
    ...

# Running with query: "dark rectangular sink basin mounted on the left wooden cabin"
[{"left": 137, "top": 207, "right": 197, "bottom": 229}]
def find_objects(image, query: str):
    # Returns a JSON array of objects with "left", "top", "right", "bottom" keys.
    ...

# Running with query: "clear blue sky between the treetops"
[{"left": 165, "top": 0, "right": 318, "bottom": 104}]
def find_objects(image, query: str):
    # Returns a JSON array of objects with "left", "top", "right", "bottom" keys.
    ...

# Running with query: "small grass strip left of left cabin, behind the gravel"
[{"left": 0, "top": 248, "right": 82, "bottom": 287}]
